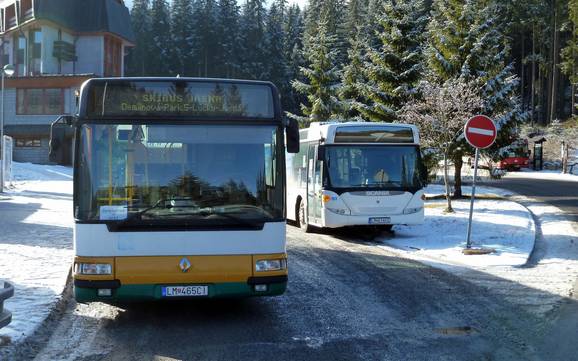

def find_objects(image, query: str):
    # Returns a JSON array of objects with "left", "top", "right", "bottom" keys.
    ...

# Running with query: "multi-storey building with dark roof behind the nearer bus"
[{"left": 0, "top": 0, "right": 134, "bottom": 163}]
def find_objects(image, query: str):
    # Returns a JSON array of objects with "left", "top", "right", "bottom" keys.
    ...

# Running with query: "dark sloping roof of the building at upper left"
[{"left": 34, "top": 0, "right": 135, "bottom": 43}]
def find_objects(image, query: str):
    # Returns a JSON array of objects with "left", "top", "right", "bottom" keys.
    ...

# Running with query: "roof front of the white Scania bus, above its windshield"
[{"left": 299, "top": 122, "right": 419, "bottom": 144}]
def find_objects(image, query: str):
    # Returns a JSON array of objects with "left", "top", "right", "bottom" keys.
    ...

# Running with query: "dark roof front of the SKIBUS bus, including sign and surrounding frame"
[{"left": 79, "top": 77, "right": 281, "bottom": 121}]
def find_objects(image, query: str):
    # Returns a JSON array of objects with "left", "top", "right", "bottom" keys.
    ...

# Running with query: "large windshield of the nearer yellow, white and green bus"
[{"left": 75, "top": 122, "right": 284, "bottom": 225}]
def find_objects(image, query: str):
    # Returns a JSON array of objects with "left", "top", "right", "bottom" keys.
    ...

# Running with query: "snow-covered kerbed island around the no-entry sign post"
[{"left": 382, "top": 185, "right": 535, "bottom": 267}]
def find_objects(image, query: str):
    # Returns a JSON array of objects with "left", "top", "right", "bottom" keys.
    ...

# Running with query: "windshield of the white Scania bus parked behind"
[{"left": 325, "top": 145, "right": 422, "bottom": 189}]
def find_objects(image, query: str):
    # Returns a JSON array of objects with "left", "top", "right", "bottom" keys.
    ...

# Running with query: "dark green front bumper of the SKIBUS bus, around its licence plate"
[{"left": 74, "top": 275, "right": 287, "bottom": 303}]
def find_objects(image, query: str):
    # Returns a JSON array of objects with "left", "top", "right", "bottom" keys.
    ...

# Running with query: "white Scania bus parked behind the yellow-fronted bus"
[{"left": 287, "top": 122, "right": 427, "bottom": 231}]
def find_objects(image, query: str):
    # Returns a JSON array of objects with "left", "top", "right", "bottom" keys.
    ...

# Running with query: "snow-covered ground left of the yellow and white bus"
[{"left": 0, "top": 163, "right": 73, "bottom": 343}]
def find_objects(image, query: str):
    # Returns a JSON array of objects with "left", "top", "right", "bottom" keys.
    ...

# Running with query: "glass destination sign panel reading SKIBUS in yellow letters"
[{"left": 87, "top": 80, "right": 274, "bottom": 119}]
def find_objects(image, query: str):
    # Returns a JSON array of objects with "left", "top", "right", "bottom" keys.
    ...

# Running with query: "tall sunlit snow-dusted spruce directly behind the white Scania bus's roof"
[{"left": 354, "top": 0, "right": 426, "bottom": 122}]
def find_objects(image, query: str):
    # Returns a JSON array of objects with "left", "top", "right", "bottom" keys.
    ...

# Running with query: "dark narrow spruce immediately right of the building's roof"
[{"left": 126, "top": 0, "right": 151, "bottom": 76}]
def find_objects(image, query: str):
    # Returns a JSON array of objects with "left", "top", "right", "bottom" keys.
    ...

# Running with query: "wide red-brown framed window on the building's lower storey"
[{"left": 16, "top": 88, "right": 64, "bottom": 115}]
